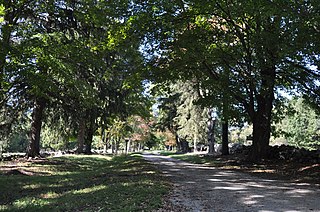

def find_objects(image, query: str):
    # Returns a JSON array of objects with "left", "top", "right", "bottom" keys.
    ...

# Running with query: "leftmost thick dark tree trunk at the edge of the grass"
[{"left": 27, "top": 98, "right": 45, "bottom": 157}]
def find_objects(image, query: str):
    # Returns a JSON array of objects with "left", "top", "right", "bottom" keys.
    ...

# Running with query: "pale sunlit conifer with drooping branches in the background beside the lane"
[{"left": 157, "top": 80, "right": 208, "bottom": 151}]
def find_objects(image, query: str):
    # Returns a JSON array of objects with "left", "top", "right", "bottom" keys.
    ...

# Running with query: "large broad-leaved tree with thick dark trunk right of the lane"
[{"left": 144, "top": 0, "right": 319, "bottom": 160}]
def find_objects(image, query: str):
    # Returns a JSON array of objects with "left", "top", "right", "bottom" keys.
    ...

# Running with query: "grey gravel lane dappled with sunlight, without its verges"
[{"left": 143, "top": 154, "right": 320, "bottom": 212}]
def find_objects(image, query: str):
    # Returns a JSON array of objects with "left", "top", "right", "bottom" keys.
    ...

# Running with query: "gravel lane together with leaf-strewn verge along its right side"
[{"left": 144, "top": 154, "right": 320, "bottom": 211}]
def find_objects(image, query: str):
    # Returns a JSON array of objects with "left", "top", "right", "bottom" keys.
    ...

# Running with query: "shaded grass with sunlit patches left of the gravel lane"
[{"left": 0, "top": 155, "right": 169, "bottom": 211}]
